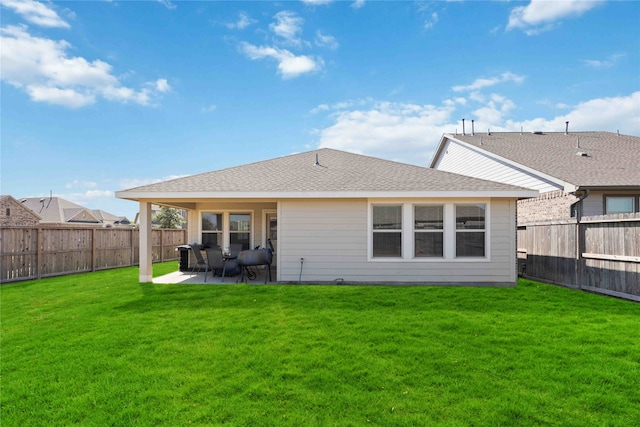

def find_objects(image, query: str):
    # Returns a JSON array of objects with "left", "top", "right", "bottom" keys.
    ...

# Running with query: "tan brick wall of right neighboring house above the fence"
[{"left": 518, "top": 190, "right": 578, "bottom": 224}]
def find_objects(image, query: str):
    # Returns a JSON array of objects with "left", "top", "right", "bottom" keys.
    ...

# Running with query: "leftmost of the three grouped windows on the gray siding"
[{"left": 373, "top": 205, "right": 402, "bottom": 258}]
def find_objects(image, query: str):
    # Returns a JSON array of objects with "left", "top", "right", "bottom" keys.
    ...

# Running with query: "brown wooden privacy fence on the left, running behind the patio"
[{"left": 0, "top": 226, "right": 187, "bottom": 283}]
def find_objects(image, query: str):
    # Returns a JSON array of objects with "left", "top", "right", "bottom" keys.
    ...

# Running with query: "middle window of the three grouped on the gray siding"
[{"left": 413, "top": 206, "right": 444, "bottom": 258}]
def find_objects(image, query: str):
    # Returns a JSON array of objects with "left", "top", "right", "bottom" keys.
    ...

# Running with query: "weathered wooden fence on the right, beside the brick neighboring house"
[{"left": 518, "top": 213, "right": 640, "bottom": 301}]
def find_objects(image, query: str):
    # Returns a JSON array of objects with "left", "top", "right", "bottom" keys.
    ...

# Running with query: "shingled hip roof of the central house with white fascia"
[{"left": 116, "top": 148, "right": 537, "bottom": 200}]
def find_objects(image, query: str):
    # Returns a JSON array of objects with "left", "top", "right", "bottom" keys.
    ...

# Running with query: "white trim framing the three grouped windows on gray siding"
[{"left": 367, "top": 199, "right": 491, "bottom": 263}]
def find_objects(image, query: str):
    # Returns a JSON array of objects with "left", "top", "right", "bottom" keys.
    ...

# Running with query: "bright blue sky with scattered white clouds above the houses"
[{"left": 0, "top": 0, "right": 640, "bottom": 219}]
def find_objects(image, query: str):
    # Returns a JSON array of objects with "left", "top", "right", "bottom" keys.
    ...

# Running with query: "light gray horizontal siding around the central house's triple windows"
[{"left": 278, "top": 199, "right": 516, "bottom": 284}]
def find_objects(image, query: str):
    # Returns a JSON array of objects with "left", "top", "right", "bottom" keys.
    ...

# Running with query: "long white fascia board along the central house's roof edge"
[{"left": 116, "top": 189, "right": 538, "bottom": 201}]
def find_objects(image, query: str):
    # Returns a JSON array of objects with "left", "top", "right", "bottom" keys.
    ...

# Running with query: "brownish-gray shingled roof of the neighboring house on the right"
[{"left": 430, "top": 132, "right": 640, "bottom": 188}]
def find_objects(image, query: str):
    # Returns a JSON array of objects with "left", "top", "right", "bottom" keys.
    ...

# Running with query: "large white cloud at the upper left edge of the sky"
[{"left": 0, "top": 26, "right": 170, "bottom": 108}]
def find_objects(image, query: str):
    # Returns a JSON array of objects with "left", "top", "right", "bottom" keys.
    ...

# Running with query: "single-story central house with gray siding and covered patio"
[{"left": 116, "top": 148, "right": 538, "bottom": 285}]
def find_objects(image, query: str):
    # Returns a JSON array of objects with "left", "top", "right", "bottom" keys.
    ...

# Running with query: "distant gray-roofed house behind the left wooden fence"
[{"left": 20, "top": 197, "right": 129, "bottom": 227}]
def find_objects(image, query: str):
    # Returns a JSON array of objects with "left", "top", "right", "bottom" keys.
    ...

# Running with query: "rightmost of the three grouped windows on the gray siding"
[{"left": 456, "top": 204, "right": 486, "bottom": 257}]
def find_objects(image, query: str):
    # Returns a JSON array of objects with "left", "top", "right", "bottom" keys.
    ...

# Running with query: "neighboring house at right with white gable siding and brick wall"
[{"left": 430, "top": 130, "right": 640, "bottom": 224}]
